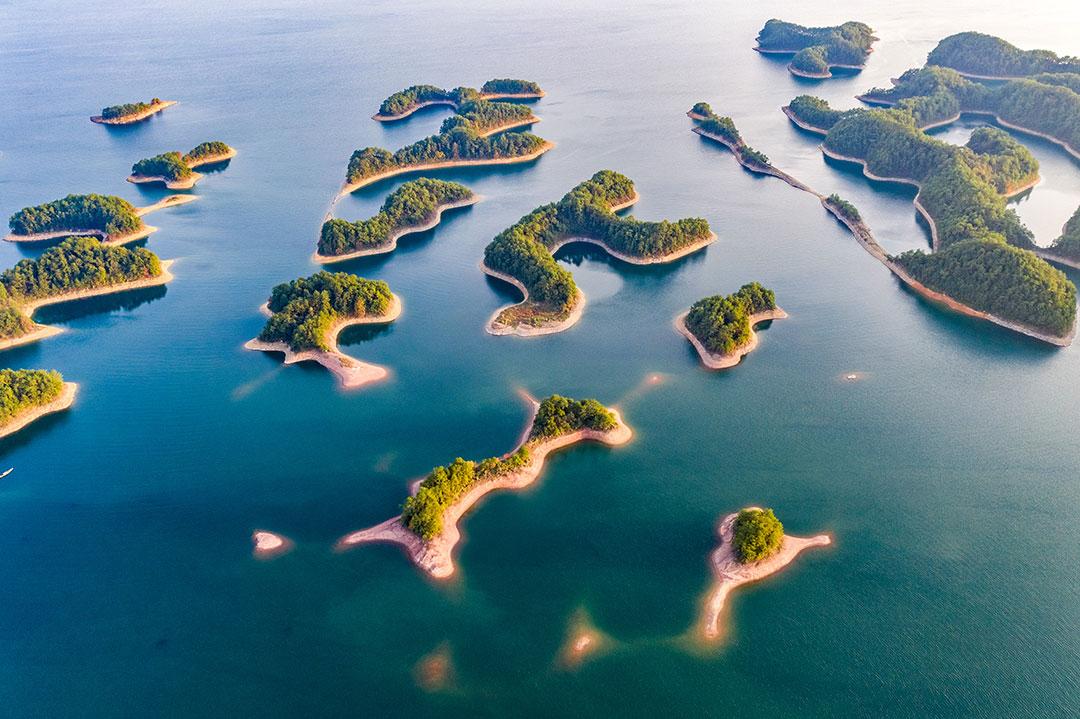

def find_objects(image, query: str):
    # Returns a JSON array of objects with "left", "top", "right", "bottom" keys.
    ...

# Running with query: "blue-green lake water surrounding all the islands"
[{"left": 0, "top": 0, "right": 1080, "bottom": 717}]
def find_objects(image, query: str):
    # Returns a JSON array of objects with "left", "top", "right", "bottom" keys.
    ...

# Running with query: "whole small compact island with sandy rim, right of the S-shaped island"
[{"left": 675, "top": 282, "right": 787, "bottom": 369}]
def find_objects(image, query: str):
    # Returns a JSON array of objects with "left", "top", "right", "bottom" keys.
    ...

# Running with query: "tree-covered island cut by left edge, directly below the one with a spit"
[{"left": 0, "top": 238, "right": 173, "bottom": 351}]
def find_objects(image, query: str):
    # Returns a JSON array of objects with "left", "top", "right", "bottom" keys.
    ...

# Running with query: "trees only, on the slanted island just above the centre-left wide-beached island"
[{"left": 319, "top": 177, "right": 473, "bottom": 255}]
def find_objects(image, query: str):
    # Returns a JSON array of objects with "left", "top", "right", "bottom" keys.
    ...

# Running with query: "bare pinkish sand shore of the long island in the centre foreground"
[{"left": 335, "top": 401, "right": 633, "bottom": 579}]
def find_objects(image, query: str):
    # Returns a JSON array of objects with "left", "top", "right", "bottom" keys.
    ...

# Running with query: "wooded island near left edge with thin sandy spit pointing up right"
[{"left": 4, "top": 194, "right": 198, "bottom": 245}]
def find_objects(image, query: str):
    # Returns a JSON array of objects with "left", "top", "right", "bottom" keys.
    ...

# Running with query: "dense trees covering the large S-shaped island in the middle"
[{"left": 484, "top": 169, "right": 710, "bottom": 324}]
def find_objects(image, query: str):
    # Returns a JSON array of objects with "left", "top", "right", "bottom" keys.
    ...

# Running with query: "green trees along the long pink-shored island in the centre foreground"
[{"left": 401, "top": 394, "right": 617, "bottom": 541}]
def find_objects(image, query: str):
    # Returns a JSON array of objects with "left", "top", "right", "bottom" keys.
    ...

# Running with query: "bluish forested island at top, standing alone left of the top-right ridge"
[{"left": 754, "top": 18, "right": 877, "bottom": 79}]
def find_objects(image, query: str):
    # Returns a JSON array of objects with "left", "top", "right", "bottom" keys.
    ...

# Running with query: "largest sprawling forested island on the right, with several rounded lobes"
[{"left": 788, "top": 98, "right": 1076, "bottom": 345}]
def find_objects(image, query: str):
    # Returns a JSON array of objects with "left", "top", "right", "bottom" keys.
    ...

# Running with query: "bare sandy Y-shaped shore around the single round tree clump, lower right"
[{"left": 701, "top": 506, "right": 833, "bottom": 640}]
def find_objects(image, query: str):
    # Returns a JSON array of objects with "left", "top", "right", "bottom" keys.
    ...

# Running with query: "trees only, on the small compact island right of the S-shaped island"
[{"left": 686, "top": 282, "right": 777, "bottom": 354}]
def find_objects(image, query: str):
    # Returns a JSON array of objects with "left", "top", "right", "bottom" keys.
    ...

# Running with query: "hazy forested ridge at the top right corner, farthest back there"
[{"left": 927, "top": 32, "right": 1080, "bottom": 78}]
